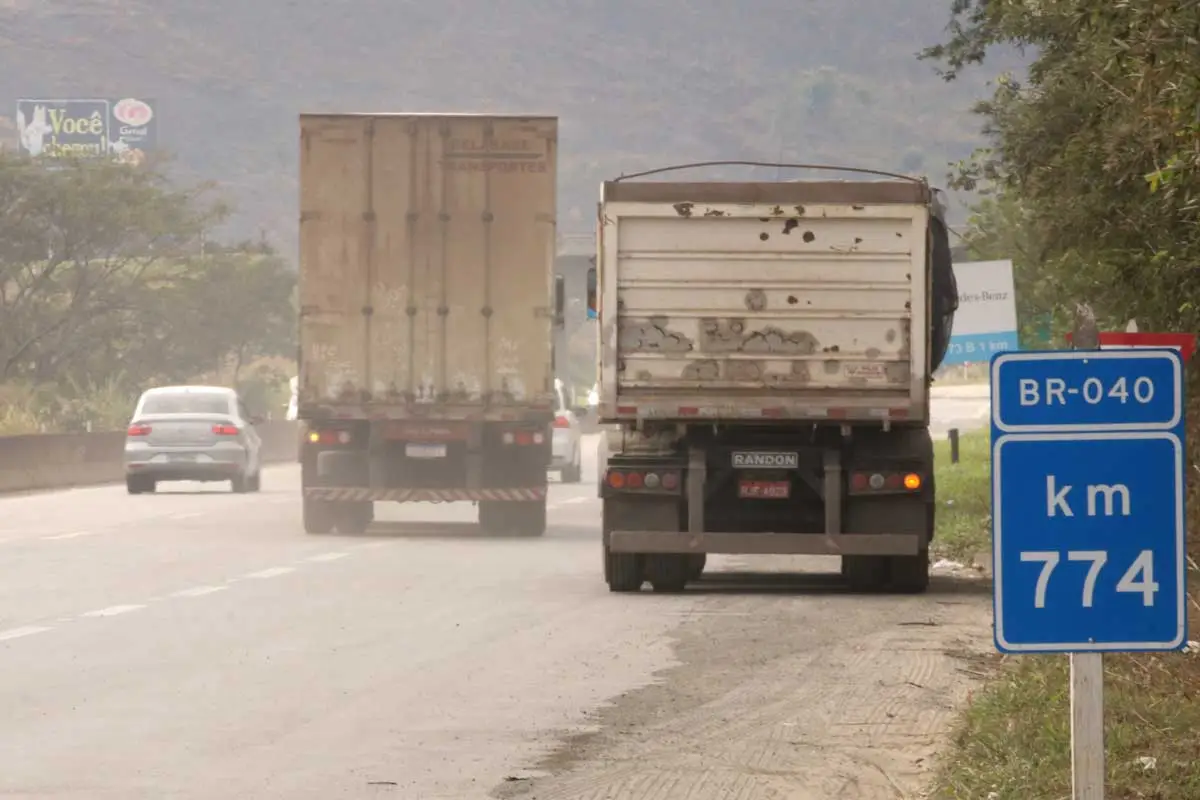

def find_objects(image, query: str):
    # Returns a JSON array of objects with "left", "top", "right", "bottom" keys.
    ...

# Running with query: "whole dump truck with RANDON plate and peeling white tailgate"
[{"left": 588, "top": 168, "right": 958, "bottom": 593}]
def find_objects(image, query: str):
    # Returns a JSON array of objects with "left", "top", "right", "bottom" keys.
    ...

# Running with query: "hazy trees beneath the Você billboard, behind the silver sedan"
[{"left": 0, "top": 156, "right": 295, "bottom": 431}]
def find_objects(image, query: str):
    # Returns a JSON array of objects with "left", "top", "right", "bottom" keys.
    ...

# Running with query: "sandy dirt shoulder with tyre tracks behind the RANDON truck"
[{"left": 494, "top": 558, "right": 990, "bottom": 800}]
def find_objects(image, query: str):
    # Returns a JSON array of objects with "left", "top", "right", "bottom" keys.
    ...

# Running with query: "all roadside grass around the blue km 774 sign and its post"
[{"left": 929, "top": 419, "right": 1200, "bottom": 800}]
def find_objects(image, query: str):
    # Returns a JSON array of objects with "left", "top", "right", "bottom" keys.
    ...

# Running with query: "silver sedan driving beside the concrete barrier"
[{"left": 125, "top": 386, "right": 263, "bottom": 494}]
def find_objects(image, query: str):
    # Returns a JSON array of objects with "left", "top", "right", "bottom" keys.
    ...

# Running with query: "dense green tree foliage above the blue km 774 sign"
[{"left": 924, "top": 0, "right": 1200, "bottom": 331}]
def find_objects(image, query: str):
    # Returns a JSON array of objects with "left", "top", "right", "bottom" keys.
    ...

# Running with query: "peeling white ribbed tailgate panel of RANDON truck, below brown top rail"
[{"left": 602, "top": 203, "right": 928, "bottom": 419}]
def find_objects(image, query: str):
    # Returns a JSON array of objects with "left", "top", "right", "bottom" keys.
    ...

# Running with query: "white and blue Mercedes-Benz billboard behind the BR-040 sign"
[{"left": 942, "top": 260, "right": 1019, "bottom": 366}]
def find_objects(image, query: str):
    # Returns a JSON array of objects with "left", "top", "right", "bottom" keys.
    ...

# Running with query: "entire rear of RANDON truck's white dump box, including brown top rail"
[{"left": 598, "top": 181, "right": 930, "bottom": 423}]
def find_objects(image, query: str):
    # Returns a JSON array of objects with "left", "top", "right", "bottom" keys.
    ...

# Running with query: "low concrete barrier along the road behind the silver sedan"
[{"left": 0, "top": 421, "right": 300, "bottom": 493}]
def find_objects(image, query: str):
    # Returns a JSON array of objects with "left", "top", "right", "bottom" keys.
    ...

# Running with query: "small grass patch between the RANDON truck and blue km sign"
[{"left": 934, "top": 431, "right": 991, "bottom": 564}]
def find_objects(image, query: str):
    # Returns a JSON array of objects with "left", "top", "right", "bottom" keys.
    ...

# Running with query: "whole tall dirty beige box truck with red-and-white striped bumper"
[{"left": 296, "top": 114, "right": 564, "bottom": 536}]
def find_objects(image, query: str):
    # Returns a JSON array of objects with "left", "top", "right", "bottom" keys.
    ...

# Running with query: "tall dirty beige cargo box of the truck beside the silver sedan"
[{"left": 298, "top": 114, "right": 558, "bottom": 420}]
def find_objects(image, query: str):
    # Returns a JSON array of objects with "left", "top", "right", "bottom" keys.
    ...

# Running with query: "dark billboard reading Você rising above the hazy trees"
[{"left": 17, "top": 97, "right": 158, "bottom": 166}]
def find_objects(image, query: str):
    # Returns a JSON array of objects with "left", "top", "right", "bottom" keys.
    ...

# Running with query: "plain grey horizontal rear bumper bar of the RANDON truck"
[{"left": 608, "top": 530, "right": 923, "bottom": 555}]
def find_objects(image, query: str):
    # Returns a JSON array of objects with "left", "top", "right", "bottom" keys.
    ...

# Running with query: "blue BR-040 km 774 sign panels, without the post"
[{"left": 991, "top": 349, "right": 1187, "bottom": 652}]
